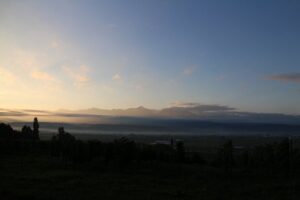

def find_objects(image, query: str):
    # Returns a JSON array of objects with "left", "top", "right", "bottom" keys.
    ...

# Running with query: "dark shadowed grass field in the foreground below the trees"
[{"left": 0, "top": 155, "right": 300, "bottom": 200}]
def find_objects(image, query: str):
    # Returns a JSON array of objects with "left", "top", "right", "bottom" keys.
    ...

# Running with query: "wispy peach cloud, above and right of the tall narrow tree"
[{"left": 62, "top": 65, "right": 90, "bottom": 88}]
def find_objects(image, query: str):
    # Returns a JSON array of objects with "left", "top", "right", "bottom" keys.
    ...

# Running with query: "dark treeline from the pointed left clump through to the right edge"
[{"left": 51, "top": 131, "right": 300, "bottom": 175}]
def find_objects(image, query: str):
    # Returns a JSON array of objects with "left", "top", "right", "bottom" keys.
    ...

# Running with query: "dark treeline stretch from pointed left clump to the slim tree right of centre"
[{"left": 51, "top": 128, "right": 190, "bottom": 165}]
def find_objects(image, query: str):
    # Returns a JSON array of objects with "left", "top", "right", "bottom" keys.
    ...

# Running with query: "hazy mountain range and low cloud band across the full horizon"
[{"left": 0, "top": 104, "right": 300, "bottom": 124}]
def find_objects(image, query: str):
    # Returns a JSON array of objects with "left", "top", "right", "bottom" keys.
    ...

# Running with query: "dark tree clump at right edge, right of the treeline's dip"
[{"left": 211, "top": 138, "right": 300, "bottom": 175}]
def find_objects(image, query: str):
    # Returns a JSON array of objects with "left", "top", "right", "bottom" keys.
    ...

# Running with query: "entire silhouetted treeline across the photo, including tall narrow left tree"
[{"left": 0, "top": 119, "right": 300, "bottom": 175}]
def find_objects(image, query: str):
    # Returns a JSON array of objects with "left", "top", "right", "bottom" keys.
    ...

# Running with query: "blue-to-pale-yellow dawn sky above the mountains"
[{"left": 0, "top": 0, "right": 300, "bottom": 114}]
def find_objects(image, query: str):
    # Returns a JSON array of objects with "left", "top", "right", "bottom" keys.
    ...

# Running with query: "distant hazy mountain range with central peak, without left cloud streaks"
[{"left": 58, "top": 105, "right": 300, "bottom": 124}]
